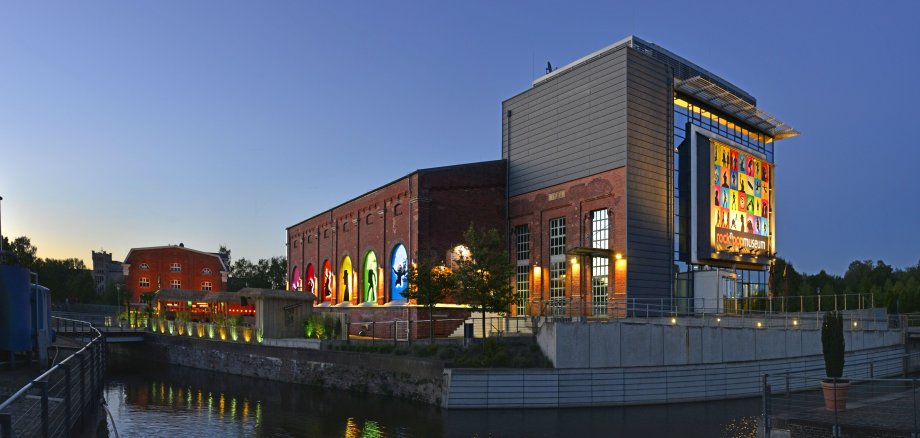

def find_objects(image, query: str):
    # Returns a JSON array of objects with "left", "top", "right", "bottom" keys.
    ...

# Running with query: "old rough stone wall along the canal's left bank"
[{"left": 145, "top": 334, "right": 444, "bottom": 405}]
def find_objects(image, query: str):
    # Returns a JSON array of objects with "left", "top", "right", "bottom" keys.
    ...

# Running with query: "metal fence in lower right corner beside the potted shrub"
[{"left": 761, "top": 353, "right": 920, "bottom": 437}]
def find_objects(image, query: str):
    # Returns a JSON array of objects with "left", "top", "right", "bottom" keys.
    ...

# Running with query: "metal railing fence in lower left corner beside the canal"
[{"left": 0, "top": 317, "right": 106, "bottom": 438}]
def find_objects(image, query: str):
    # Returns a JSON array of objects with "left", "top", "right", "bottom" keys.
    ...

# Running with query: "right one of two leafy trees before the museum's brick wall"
[{"left": 455, "top": 224, "right": 514, "bottom": 336}]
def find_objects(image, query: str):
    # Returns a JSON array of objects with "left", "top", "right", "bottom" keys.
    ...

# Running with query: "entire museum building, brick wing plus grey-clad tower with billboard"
[{"left": 288, "top": 36, "right": 799, "bottom": 316}]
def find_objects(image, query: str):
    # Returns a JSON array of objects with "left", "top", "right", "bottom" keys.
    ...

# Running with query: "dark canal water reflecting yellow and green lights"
[{"left": 105, "top": 360, "right": 760, "bottom": 438}]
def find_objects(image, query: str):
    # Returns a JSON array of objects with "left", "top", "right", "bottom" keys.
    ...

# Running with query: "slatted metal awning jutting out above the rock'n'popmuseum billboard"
[{"left": 674, "top": 76, "right": 800, "bottom": 140}]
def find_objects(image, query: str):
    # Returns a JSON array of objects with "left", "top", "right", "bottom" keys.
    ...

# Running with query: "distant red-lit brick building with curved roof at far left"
[{"left": 123, "top": 243, "right": 228, "bottom": 303}]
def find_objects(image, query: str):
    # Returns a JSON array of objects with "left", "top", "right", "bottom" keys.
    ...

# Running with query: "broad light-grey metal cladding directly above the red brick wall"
[{"left": 502, "top": 47, "right": 629, "bottom": 196}]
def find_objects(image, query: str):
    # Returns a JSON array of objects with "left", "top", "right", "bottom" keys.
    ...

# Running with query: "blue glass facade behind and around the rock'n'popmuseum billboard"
[{"left": 673, "top": 97, "right": 774, "bottom": 297}]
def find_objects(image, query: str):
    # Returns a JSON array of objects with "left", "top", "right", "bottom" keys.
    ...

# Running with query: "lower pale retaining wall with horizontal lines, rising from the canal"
[{"left": 442, "top": 346, "right": 905, "bottom": 409}]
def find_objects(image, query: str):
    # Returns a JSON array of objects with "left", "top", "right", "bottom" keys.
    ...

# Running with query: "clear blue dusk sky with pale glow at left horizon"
[{"left": 0, "top": 1, "right": 920, "bottom": 273}]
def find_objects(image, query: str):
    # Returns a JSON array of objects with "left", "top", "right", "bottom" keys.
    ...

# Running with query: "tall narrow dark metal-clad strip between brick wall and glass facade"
[{"left": 626, "top": 49, "right": 674, "bottom": 298}]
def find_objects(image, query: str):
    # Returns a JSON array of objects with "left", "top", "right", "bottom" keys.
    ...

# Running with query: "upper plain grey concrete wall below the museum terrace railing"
[{"left": 537, "top": 320, "right": 904, "bottom": 368}]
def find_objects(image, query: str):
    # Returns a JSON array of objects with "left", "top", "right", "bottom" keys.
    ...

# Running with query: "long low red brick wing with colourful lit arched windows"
[{"left": 287, "top": 161, "right": 505, "bottom": 304}]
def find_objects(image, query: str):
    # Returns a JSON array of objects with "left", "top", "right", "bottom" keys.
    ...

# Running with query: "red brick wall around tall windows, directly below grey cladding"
[{"left": 509, "top": 167, "right": 626, "bottom": 314}]
